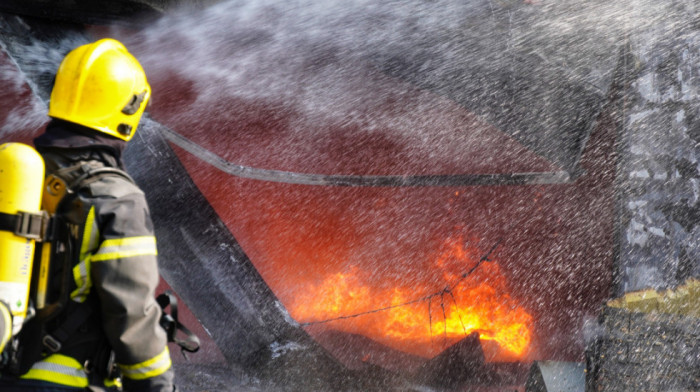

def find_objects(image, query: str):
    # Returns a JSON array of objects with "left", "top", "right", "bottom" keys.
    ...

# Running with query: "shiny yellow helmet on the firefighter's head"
[{"left": 49, "top": 38, "right": 151, "bottom": 141}]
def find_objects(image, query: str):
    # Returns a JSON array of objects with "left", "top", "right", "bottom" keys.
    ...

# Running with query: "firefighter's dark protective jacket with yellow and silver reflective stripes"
[{"left": 15, "top": 120, "right": 174, "bottom": 392}]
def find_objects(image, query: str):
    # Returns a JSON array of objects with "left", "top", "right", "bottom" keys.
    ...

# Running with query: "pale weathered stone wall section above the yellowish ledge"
[{"left": 615, "top": 0, "right": 700, "bottom": 296}]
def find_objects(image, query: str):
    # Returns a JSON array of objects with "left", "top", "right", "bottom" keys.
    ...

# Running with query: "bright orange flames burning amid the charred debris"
[{"left": 289, "top": 236, "right": 532, "bottom": 360}]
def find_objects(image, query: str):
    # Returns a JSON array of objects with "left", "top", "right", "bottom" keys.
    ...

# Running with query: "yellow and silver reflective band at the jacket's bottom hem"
[{"left": 21, "top": 354, "right": 88, "bottom": 388}]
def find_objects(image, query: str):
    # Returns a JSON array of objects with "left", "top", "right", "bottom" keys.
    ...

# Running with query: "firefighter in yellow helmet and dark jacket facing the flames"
[{"left": 0, "top": 39, "right": 176, "bottom": 392}]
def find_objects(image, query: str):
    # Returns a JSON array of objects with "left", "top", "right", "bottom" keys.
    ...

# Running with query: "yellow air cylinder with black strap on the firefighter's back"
[{"left": 0, "top": 143, "right": 44, "bottom": 351}]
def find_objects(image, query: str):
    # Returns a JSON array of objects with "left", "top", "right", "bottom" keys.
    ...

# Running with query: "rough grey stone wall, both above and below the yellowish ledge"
[{"left": 586, "top": 0, "right": 700, "bottom": 392}]
